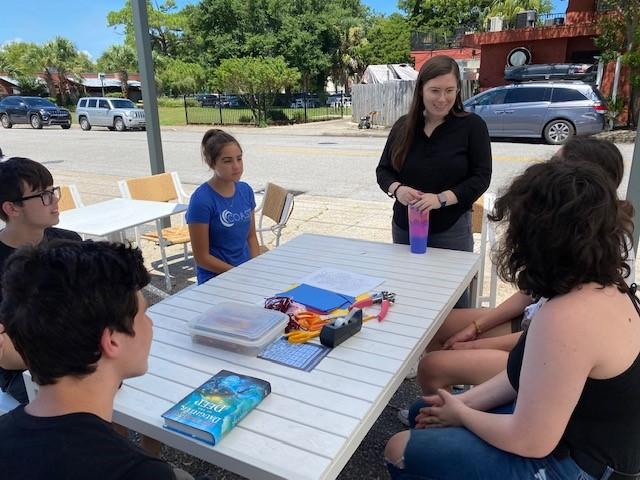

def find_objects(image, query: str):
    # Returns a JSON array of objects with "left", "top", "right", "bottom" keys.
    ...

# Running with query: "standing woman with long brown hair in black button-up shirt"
[{"left": 376, "top": 56, "right": 491, "bottom": 307}]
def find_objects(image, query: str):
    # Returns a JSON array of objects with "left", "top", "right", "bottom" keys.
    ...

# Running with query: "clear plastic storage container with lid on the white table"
[{"left": 188, "top": 302, "right": 289, "bottom": 355}]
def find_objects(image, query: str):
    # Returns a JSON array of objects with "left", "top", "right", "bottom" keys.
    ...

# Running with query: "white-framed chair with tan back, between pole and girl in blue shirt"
[{"left": 118, "top": 172, "right": 191, "bottom": 290}]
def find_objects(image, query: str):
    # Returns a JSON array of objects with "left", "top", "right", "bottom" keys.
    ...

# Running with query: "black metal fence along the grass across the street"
[{"left": 184, "top": 92, "right": 351, "bottom": 125}]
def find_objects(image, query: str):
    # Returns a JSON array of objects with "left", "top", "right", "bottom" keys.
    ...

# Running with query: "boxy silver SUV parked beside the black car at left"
[{"left": 76, "top": 97, "right": 146, "bottom": 132}]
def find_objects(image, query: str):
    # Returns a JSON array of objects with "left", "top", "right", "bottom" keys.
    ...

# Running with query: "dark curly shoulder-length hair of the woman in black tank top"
[{"left": 489, "top": 159, "right": 632, "bottom": 297}]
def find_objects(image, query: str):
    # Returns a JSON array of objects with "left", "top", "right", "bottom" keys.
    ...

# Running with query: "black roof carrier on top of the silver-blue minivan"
[{"left": 504, "top": 63, "right": 598, "bottom": 83}]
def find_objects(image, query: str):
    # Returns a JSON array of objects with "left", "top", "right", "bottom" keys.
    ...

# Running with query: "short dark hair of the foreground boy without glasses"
[{"left": 0, "top": 240, "right": 150, "bottom": 385}]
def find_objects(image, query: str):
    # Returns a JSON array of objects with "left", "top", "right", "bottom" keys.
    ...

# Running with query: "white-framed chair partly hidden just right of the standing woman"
[{"left": 472, "top": 193, "right": 498, "bottom": 307}]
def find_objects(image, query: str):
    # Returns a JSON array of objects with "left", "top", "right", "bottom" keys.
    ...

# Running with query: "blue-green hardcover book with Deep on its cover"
[{"left": 162, "top": 370, "right": 271, "bottom": 445}]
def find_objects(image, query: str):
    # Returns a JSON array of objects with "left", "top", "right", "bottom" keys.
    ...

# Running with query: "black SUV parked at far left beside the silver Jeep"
[{"left": 0, "top": 95, "right": 71, "bottom": 130}]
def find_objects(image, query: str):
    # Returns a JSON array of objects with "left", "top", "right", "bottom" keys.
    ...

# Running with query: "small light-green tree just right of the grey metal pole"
[{"left": 157, "top": 57, "right": 207, "bottom": 96}]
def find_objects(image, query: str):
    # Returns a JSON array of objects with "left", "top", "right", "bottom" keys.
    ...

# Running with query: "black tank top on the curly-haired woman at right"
[{"left": 507, "top": 293, "right": 640, "bottom": 477}]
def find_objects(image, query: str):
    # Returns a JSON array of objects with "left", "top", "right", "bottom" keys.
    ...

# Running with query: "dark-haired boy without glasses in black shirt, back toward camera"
[{"left": 0, "top": 241, "right": 198, "bottom": 480}]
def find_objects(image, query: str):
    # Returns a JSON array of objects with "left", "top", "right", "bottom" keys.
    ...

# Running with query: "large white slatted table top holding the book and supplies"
[{"left": 114, "top": 235, "right": 479, "bottom": 480}]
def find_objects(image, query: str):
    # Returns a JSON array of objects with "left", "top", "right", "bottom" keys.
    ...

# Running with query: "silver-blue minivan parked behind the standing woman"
[{"left": 464, "top": 81, "right": 607, "bottom": 145}]
